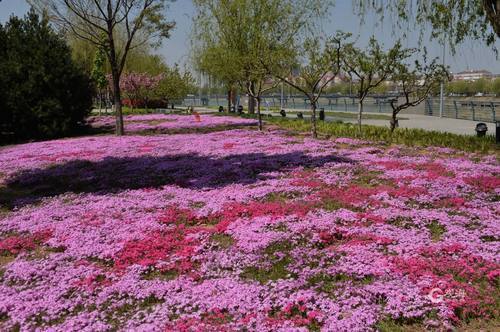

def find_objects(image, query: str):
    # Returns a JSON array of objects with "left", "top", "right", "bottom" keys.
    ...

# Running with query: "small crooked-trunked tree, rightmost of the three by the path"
[{"left": 390, "top": 56, "right": 449, "bottom": 133}]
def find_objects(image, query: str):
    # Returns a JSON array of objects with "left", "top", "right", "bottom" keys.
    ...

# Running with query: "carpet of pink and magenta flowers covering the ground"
[{"left": 0, "top": 116, "right": 500, "bottom": 331}]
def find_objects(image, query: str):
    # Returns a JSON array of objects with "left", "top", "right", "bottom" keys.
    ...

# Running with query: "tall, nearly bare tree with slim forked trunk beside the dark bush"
[{"left": 29, "top": 0, "right": 174, "bottom": 135}]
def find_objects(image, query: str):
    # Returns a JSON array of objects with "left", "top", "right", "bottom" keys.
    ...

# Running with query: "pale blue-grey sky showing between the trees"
[{"left": 0, "top": 0, "right": 500, "bottom": 73}]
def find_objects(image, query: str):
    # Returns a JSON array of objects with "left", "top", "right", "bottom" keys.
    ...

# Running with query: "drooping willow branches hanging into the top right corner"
[{"left": 356, "top": 0, "right": 500, "bottom": 50}]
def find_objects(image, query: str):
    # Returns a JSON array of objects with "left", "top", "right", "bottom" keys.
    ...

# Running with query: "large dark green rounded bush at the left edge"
[{"left": 0, "top": 11, "right": 93, "bottom": 141}]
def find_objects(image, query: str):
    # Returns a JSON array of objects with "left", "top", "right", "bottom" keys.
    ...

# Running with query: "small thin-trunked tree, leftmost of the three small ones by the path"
[{"left": 275, "top": 32, "right": 350, "bottom": 138}]
